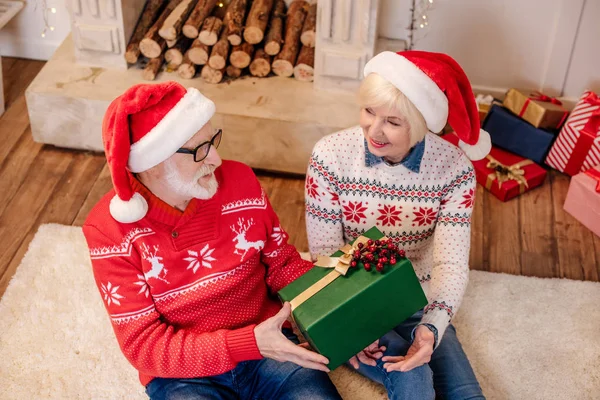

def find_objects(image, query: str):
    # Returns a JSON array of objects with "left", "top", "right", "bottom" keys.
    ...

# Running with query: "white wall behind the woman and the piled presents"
[{"left": 378, "top": 0, "right": 600, "bottom": 98}]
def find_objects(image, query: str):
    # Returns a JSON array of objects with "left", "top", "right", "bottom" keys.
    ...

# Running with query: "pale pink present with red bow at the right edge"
[{"left": 563, "top": 166, "right": 600, "bottom": 236}]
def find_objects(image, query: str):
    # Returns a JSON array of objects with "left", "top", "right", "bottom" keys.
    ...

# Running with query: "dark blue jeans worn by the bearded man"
[{"left": 146, "top": 329, "right": 341, "bottom": 400}]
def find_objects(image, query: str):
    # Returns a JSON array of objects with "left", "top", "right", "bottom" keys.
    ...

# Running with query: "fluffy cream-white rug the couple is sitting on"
[{"left": 0, "top": 224, "right": 600, "bottom": 400}]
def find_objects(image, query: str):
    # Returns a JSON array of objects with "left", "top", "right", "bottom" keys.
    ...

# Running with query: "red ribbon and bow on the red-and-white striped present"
[{"left": 561, "top": 91, "right": 600, "bottom": 175}]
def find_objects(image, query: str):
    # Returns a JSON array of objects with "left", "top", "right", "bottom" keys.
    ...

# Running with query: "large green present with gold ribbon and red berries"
[{"left": 279, "top": 228, "right": 427, "bottom": 370}]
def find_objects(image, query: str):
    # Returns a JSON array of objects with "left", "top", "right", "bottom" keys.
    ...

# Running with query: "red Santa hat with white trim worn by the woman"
[{"left": 364, "top": 50, "right": 492, "bottom": 161}]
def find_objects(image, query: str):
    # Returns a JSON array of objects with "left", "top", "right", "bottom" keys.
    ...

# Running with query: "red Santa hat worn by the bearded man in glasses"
[{"left": 102, "top": 82, "right": 215, "bottom": 223}]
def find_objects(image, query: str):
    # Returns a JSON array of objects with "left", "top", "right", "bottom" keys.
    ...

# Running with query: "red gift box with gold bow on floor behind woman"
[{"left": 442, "top": 133, "right": 546, "bottom": 201}]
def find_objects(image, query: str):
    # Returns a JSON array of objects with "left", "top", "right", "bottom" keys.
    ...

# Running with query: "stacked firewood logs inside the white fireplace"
[{"left": 125, "top": 0, "right": 317, "bottom": 83}]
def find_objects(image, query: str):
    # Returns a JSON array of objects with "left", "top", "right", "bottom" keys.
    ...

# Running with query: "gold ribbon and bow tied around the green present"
[{"left": 290, "top": 236, "right": 387, "bottom": 311}]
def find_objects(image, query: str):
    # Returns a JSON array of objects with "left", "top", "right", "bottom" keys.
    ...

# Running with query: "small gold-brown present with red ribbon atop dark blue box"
[{"left": 502, "top": 89, "right": 569, "bottom": 129}]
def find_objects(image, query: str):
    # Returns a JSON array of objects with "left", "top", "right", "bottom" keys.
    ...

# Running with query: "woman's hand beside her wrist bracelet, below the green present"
[{"left": 383, "top": 325, "right": 435, "bottom": 372}]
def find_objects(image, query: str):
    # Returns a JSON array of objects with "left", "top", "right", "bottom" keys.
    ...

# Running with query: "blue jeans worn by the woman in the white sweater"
[{"left": 350, "top": 311, "right": 485, "bottom": 400}]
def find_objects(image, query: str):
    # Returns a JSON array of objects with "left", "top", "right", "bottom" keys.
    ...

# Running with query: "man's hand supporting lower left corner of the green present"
[{"left": 254, "top": 302, "right": 329, "bottom": 372}]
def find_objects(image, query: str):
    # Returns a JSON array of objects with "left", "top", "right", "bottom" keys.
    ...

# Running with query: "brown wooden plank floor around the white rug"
[{"left": 0, "top": 58, "right": 600, "bottom": 296}]
